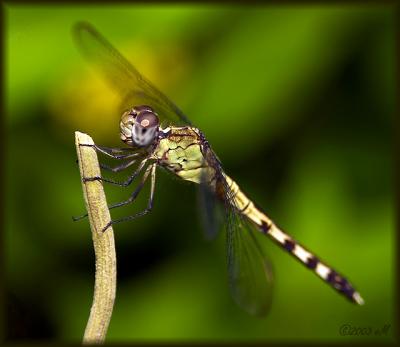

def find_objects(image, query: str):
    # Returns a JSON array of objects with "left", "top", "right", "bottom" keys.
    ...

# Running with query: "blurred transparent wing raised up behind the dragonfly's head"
[{"left": 74, "top": 22, "right": 190, "bottom": 125}]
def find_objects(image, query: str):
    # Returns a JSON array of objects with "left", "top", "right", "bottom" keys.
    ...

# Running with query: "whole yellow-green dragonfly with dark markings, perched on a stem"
[{"left": 74, "top": 22, "right": 364, "bottom": 316}]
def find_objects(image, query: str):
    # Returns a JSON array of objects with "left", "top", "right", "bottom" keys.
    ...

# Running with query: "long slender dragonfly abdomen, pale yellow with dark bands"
[{"left": 225, "top": 175, "right": 364, "bottom": 305}]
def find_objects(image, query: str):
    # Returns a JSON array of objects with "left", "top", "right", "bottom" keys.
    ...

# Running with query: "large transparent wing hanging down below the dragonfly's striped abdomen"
[{"left": 207, "top": 150, "right": 273, "bottom": 316}]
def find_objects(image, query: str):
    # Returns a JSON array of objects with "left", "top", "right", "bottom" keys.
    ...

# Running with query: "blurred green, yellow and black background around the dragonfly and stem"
[{"left": 5, "top": 4, "right": 395, "bottom": 341}]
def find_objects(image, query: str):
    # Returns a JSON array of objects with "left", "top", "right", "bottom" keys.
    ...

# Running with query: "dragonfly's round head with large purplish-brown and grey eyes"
[{"left": 120, "top": 105, "right": 160, "bottom": 147}]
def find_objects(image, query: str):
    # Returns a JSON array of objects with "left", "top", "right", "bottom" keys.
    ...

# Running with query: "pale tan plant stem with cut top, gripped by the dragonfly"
[{"left": 75, "top": 131, "right": 117, "bottom": 344}]
